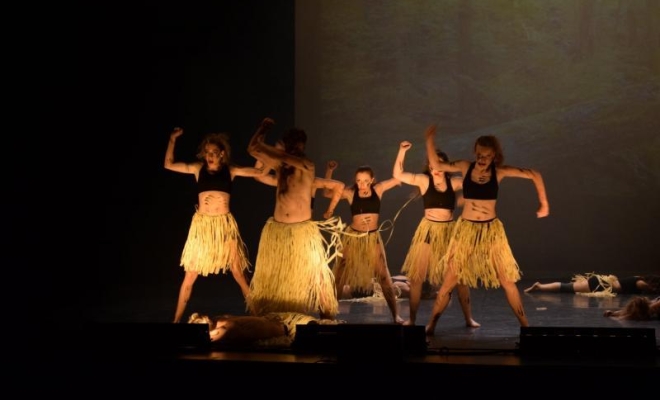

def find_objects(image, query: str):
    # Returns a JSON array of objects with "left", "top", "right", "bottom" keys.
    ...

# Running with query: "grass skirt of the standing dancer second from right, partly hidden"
[{"left": 401, "top": 217, "right": 456, "bottom": 286}]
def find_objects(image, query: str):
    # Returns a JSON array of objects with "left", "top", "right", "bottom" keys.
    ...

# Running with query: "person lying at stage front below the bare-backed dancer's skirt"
[{"left": 188, "top": 312, "right": 342, "bottom": 347}]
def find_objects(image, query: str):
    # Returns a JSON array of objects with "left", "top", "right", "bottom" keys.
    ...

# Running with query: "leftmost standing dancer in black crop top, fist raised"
[{"left": 165, "top": 127, "right": 263, "bottom": 323}]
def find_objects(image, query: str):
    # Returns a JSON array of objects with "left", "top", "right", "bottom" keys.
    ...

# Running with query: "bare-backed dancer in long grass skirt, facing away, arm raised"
[{"left": 248, "top": 118, "right": 341, "bottom": 319}]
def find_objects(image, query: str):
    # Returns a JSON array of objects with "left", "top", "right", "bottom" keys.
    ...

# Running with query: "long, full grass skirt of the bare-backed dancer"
[{"left": 247, "top": 217, "right": 339, "bottom": 317}]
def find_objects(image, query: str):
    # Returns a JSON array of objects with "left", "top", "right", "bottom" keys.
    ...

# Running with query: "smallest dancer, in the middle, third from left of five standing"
[{"left": 325, "top": 161, "right": 404, "bottom": 323}]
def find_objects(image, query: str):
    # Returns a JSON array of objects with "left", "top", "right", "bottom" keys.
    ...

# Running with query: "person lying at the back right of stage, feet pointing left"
[{"left": 525, "top": 273, "right": 660, "bottom": 297}]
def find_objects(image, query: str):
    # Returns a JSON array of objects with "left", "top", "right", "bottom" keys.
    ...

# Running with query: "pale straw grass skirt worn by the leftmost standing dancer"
[{"left": 180, "top": 212, "right": 250, "bottom": 276}]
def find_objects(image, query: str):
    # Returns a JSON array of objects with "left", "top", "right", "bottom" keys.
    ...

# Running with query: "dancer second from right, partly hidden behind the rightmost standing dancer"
[{"left": 392, "top": 141, "right": 481, "bottom": 328}]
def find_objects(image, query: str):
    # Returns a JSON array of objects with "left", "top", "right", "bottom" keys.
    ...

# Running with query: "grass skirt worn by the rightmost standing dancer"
[{"left": 429, "top": 217, "right": 521, "bottom": 289}]
